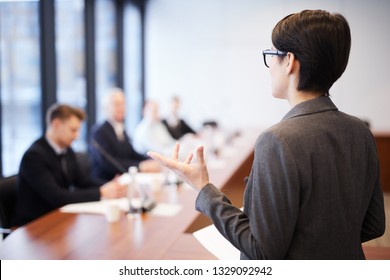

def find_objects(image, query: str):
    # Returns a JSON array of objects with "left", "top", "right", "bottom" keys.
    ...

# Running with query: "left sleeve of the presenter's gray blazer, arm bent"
[{"left": 196, "top": 133, "right": 299, "bottom": 259}]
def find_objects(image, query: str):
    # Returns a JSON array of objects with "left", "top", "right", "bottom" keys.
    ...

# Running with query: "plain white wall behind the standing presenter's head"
[{"left": 146, "top": 0, "right": 390, "bottom": 130}]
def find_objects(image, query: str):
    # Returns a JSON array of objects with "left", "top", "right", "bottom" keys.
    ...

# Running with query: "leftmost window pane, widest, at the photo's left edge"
[{"left": 0, "top": 1, "right": 42, "bottom": 176}]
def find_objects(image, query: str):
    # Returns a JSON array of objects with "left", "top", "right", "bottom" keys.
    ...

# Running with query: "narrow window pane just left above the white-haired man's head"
[{"left": 95, "top": 0, "right": 117, "bottom": 122}]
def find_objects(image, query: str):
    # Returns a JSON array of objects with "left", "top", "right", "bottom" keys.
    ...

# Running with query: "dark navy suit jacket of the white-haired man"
[{"left": 90, "top": 121, "right": 148, "bottom": 181}]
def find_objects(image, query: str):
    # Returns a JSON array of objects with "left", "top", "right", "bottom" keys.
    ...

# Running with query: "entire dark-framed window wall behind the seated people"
[{"left": 0, "top": 0, "right": 144, "bottom": 176}]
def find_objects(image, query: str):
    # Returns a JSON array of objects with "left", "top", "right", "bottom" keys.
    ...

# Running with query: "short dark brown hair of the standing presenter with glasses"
[{"left": 272, "top": 10, "right": 351, "bottom": 96}]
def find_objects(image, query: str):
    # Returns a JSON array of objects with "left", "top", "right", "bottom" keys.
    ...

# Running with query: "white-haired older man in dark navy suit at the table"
[{"left": 90, "top": 88, "right": 160, "bottom": 183}]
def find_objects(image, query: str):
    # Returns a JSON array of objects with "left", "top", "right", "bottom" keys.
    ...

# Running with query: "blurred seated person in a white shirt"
[{"left": 134, "top": 100, "right": 176, "bottom": 155}]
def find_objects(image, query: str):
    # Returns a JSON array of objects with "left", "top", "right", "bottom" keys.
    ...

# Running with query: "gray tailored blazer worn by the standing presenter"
[{"left": 196, "top": 97, "right": 385, "bottom": 259}]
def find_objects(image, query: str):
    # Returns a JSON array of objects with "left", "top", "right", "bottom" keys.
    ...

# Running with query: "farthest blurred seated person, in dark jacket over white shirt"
[{"left": 162, "top": 96, "right": 196, "bottom": 139}]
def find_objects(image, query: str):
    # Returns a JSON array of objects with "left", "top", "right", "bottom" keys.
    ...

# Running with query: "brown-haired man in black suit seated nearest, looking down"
[{"left": 15, "top": 104, "right": 127, "bottom": 226}]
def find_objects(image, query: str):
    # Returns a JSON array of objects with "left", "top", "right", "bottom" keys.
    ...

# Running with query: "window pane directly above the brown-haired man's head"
[{"left": 55, "top": 0, "right": 87, "bottom": 151}]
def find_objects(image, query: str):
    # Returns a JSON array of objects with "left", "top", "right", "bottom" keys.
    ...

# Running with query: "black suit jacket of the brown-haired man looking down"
[{"left": 15, "top": 137, "right": 100, "bottom": 226}]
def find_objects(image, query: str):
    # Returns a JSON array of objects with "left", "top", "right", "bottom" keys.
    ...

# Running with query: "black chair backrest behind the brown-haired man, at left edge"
[{"left": 0, "top": 175, "right": 17, "bottom": 238}]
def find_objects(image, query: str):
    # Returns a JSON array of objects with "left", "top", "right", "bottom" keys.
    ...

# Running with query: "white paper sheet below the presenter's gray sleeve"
[{"left": 193, "top": 225, "right": 240, "bottom": 260}]
